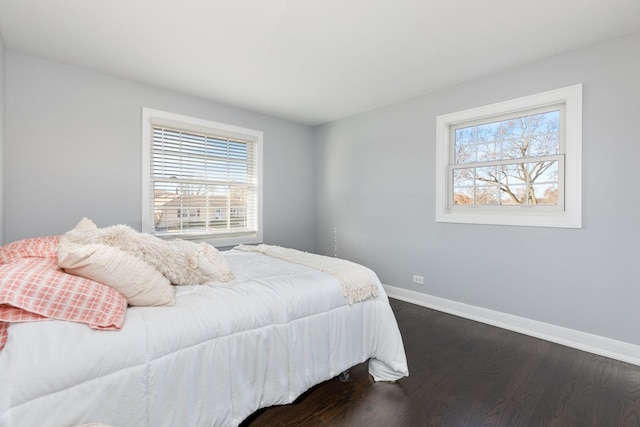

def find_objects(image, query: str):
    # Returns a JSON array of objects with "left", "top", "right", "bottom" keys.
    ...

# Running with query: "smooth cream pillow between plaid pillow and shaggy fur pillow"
[{"left": 58, "top": 241, "right": 175, "bottom": 306}]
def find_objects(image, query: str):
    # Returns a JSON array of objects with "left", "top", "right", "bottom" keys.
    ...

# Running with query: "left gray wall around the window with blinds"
[{"left": 0, "top": 50, "right": 314, "bottom": 250}]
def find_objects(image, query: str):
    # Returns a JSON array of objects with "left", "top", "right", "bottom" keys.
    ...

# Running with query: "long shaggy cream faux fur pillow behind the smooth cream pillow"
[{"left": 65, "top": 218, "right": 210, "bottom": 285}]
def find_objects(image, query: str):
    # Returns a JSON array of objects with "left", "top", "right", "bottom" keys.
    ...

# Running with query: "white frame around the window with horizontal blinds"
[{"left": 142, "top": 108, "right": 263, "bottom": 247}]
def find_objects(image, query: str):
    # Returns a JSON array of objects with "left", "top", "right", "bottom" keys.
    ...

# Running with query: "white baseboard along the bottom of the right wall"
[{"left": 384, "top": 285, "right": 640, "bottom": 366}]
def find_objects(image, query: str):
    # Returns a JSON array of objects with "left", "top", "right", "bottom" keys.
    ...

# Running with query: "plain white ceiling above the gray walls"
[{"left": 0, "top": 0, "right": 640, "bottom": 125}]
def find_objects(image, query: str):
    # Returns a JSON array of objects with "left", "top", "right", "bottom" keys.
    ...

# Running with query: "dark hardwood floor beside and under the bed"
[{"left": 242, "top": 300, "right": 640, "bottom": 427}]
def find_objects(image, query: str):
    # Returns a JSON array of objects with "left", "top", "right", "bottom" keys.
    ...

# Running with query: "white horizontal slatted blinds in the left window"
[{"left": 150, "top": 121, "right": 259, "bottom": 238}]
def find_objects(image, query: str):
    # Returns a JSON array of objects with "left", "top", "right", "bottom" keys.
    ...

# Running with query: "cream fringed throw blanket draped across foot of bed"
[{"left": 235, "top": 245, "right": 378, "bottom": 304}]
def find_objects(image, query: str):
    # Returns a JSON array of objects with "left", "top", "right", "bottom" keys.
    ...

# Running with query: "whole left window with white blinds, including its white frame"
[{"left": 142, "top": 108, "right": 262, "bottom": 246}]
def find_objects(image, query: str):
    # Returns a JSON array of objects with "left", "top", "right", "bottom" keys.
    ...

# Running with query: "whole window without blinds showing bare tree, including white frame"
[{"left": 436, "top": 85, "right": 582, "bottom": 228}]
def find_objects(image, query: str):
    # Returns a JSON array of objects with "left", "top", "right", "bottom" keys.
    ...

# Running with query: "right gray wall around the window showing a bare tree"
[{"left": 315, "top": 33, "right": 640, "bottom": 344}]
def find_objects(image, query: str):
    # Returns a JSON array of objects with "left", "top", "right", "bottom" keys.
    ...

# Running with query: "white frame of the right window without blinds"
[{"left": 436, "top": 84, "right": 582, "bottom": 228}]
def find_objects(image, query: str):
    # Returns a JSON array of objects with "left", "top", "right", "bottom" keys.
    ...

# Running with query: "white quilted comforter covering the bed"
[{"left": 0, "top": 251, "right": 407, "bottom": 427}]
